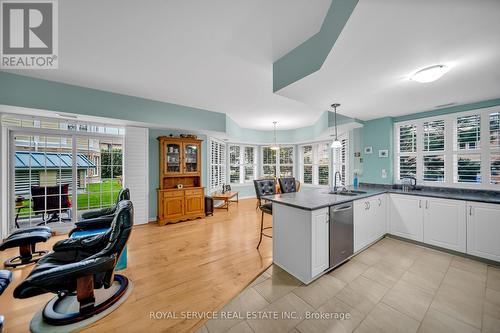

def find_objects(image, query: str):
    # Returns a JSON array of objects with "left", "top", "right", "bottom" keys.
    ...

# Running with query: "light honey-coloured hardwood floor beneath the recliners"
[{"left": 0, "top": 199, "right": 272, "bottom": 333}]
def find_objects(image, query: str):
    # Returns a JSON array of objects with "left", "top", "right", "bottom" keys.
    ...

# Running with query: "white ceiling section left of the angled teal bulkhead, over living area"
[{"left": 6, "top": 0, "right": 331, "bottom": 129}]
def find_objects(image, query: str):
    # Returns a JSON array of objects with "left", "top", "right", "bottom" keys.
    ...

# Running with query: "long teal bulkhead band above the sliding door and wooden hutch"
[{"left": 0, "top": 72, "right": 226, "bottom": 132}]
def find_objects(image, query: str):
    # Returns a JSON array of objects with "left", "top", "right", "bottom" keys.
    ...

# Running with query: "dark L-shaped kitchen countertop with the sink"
[{"left": 263, "top": 184, "right": 500, "bottom": 210}]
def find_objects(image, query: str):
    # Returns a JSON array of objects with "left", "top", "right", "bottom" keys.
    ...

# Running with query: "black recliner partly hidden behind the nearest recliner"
[{"left": 69, "top": 188, "right": 130, "bottom": 236}]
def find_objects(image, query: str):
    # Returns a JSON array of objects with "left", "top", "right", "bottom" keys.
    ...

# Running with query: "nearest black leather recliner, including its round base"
[{"left": 14, "top": 200, "right": 134, "bottom": 325}]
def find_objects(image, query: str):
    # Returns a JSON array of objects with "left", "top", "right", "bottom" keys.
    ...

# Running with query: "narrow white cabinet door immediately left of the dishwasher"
[{"left": 311, "top": 208, "right": 330, "bottom": 277}]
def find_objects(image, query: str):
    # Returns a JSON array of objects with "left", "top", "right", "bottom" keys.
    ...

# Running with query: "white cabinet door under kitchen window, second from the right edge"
[{"left": 422, "top": 198, "right": 466, "bottom": 253}]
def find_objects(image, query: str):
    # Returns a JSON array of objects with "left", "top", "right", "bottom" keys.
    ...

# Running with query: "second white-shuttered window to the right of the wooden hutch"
[{"left": 229, "top": 145, "right": 257, "bottom": 184}]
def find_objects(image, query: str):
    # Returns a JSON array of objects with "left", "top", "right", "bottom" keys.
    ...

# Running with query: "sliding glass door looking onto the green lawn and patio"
[{"left": 9, "top": 129, "right": 123, "bottom": 232}]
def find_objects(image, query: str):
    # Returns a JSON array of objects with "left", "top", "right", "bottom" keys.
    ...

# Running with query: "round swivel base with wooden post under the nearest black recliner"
[{"left": 42, "top": 274, "right": 129, "bottom": 326}]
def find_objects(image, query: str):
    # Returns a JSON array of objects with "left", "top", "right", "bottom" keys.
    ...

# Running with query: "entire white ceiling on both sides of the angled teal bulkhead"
[{"left": 7, "top": 0, "right": 500, "bottom": 129}]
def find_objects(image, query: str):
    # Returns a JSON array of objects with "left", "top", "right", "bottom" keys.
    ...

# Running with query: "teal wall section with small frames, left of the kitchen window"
[{"left": 358, "top": 117, "right": 394, "bottom": 184}]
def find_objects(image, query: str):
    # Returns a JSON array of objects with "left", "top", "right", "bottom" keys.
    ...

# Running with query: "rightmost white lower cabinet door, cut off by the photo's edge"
[{"left": 467, "top": 202, "right": 500, "bottom": 261}]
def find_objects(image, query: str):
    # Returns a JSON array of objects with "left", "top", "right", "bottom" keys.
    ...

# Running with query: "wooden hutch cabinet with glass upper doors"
[{"left": 158, "top": 136, "right": 205, "bottom": 225}]
